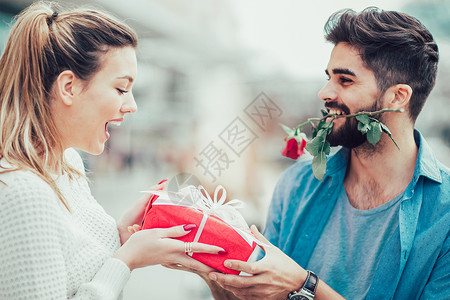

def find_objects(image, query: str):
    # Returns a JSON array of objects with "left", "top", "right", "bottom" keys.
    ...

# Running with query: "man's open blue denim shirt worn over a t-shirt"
[{"left": 264, "top": 130, "right": 450, "bottom": 299}]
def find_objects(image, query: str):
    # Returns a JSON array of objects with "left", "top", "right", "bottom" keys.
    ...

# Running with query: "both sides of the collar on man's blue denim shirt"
[{"left": 325, "top": 129, "right": 442, "bottom": 185}]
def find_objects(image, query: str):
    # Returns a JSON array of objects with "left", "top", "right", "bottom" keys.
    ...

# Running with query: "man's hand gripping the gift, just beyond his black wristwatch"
[{"left": 209, "top": 225, "right": 307, "bottom": 300}]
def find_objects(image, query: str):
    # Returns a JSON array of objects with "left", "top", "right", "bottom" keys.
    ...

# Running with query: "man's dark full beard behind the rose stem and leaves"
[{"left": 326, "top": 98, "right": 382, "bottom": 149}]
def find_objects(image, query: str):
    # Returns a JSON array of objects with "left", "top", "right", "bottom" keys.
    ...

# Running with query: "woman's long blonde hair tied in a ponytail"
[{"left": 0, "top": 2, "right": 137, "bottom": 211}]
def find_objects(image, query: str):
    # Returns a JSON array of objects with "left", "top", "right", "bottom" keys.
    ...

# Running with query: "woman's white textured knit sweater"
[{"left": 0, "top": 149, "right": 130, "bottom": 300}]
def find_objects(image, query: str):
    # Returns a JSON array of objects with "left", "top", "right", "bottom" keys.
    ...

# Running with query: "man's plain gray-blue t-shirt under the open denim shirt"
[{"left": 306, "top": 188, "right": 403, "bottom": 300}]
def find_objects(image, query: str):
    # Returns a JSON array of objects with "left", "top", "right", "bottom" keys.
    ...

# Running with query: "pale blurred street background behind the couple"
[{"left": 0, "top": 0, "right": 450, "bottom": 300}]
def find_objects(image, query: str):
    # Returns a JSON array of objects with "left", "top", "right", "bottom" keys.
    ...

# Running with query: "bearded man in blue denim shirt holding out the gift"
[{"left": 205, "top": 8, "right": 450, "bottom": 299}]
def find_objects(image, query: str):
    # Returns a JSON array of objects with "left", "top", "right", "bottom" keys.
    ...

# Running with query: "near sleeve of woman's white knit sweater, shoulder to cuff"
[{"left": 0, "top": 171, "right": 130, "bottom": 299}]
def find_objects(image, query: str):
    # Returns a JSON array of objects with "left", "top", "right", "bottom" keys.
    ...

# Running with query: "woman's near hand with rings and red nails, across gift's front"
[{"left": 113, "top": 224, "right": 226, "bottom": 272}]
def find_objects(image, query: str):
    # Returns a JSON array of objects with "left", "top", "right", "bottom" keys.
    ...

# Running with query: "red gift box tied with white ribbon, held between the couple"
[{"left": 142, "top": 186, "right": 257, "bottom": 275}]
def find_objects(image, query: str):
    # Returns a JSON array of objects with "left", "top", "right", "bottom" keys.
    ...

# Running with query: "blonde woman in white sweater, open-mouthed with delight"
[{"left": 0, "top": 3, "right": 225, "bottom": 299}]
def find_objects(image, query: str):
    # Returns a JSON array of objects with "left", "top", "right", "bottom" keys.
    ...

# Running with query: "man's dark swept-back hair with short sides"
[{"left": 325, "top": 7, "right": 439, "bottom": 122}]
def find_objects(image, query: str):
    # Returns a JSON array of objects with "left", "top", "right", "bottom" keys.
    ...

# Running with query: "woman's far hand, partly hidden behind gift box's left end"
[{"left": 117, "top": 179, "right": 167, "bottom": 245}]
